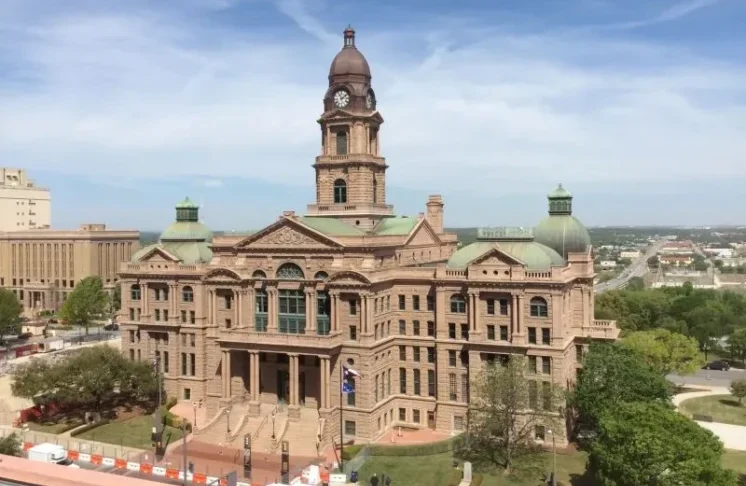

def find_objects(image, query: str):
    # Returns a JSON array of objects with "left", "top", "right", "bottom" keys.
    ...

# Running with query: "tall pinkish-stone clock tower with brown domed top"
[{"left": 308, "top": 27, "right": 394, "bottom": 230}]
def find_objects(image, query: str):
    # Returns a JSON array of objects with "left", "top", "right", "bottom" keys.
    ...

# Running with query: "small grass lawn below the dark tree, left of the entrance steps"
[{"left": 77, "top": 415, "right": 182, "bottom": 449}]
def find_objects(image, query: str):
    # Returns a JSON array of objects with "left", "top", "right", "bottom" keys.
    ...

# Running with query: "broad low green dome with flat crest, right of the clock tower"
[{"left": 448, "top": 228, "right": 565, "bottom": 270}]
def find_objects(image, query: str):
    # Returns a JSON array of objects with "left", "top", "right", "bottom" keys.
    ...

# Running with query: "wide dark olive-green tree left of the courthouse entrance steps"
[{"left": 11, "top": 346, "right": 158, "bottom": 412}]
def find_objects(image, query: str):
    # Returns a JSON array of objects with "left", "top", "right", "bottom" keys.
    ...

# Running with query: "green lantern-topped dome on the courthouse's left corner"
[{"left": 132, "top": 198, "right": 212, "bottom": 265}]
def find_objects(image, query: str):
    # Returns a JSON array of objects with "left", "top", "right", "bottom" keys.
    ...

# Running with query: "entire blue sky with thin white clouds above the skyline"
[{"left": 0, "top": 0, "right": 746, "bottom": 231}]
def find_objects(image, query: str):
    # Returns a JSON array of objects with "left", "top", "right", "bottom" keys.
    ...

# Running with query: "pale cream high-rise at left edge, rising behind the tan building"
[{"left": 0, "top": 167, "right": 52, "bottom": 231}]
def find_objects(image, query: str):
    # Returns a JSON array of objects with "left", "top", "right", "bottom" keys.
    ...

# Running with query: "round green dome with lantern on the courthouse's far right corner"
[{"left": 534, "top": 184, "right": 591, "bottom": 258}]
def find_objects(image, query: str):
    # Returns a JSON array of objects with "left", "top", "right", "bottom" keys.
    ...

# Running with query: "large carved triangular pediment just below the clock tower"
[{"left": 235, "top": 216, "right": 342, "bottom": 249}]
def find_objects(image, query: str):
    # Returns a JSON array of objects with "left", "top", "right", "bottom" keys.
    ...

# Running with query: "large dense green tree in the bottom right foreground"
[{"left": 588, "top": 403, "right": 736, "bottom": 486}]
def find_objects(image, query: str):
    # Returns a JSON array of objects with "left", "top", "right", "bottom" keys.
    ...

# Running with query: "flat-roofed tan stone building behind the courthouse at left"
[{"left": 0, "top": 224, "right": 140, "bottom": 316}]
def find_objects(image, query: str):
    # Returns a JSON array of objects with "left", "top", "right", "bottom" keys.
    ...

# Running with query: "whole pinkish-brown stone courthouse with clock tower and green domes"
[{"left": 120, "top": 28, "right": 618, "bottom": 451}]
